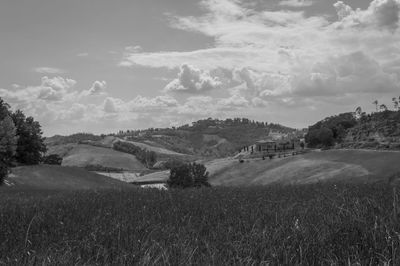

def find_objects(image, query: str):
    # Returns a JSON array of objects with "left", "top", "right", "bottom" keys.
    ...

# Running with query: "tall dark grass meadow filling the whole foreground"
[{"left": 0, "top": 184, "right": 400, "bottom": 265}]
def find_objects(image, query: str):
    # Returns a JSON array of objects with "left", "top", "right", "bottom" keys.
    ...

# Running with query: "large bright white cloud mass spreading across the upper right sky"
[{"left": 121, "top": 0, "right": 400, "bottom": 111}]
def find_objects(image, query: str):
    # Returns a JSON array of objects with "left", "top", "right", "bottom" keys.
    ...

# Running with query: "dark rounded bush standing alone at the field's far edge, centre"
[{"left": 167, "top": 163, "right": 211, "bottom": 188}]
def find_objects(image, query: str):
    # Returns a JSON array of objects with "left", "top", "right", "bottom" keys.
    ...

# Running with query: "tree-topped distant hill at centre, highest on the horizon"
[{"left": 116, "top": 118, "right": 303, "bottom": 158}]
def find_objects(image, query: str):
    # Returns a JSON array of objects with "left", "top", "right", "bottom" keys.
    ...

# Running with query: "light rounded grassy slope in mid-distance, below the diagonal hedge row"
[{"left": 62, "top": 144, "right": 146, "bottom": 171}]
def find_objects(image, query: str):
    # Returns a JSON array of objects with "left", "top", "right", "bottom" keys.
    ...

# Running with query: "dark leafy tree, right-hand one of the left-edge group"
[{"left": 12, "top": 110, "right": 47, "bottom": 164}]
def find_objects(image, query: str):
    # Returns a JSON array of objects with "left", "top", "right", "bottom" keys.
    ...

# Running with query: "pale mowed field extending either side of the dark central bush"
[{"left": 140, "top": 150, "right": 400, "bottom": 186}]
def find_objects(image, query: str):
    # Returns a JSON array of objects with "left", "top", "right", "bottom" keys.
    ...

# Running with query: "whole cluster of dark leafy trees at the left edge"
[{"left": 0, "top": 98, "right": 46, "bottom": 184}]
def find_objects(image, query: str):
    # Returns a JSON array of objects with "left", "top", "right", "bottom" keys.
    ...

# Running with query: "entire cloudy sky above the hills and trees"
[{"left": 0, "top": 0, "right": 400, "bottom": 136}]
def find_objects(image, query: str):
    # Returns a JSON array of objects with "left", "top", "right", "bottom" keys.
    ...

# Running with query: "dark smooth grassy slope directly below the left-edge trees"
[{"left": 7, "top": 165, "right": 127, "bottom": 190}]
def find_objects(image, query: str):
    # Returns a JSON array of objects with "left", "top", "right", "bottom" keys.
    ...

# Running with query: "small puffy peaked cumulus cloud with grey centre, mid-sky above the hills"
[{"left": 164, "top": 64, "right": 221, "bottom": 94}]
